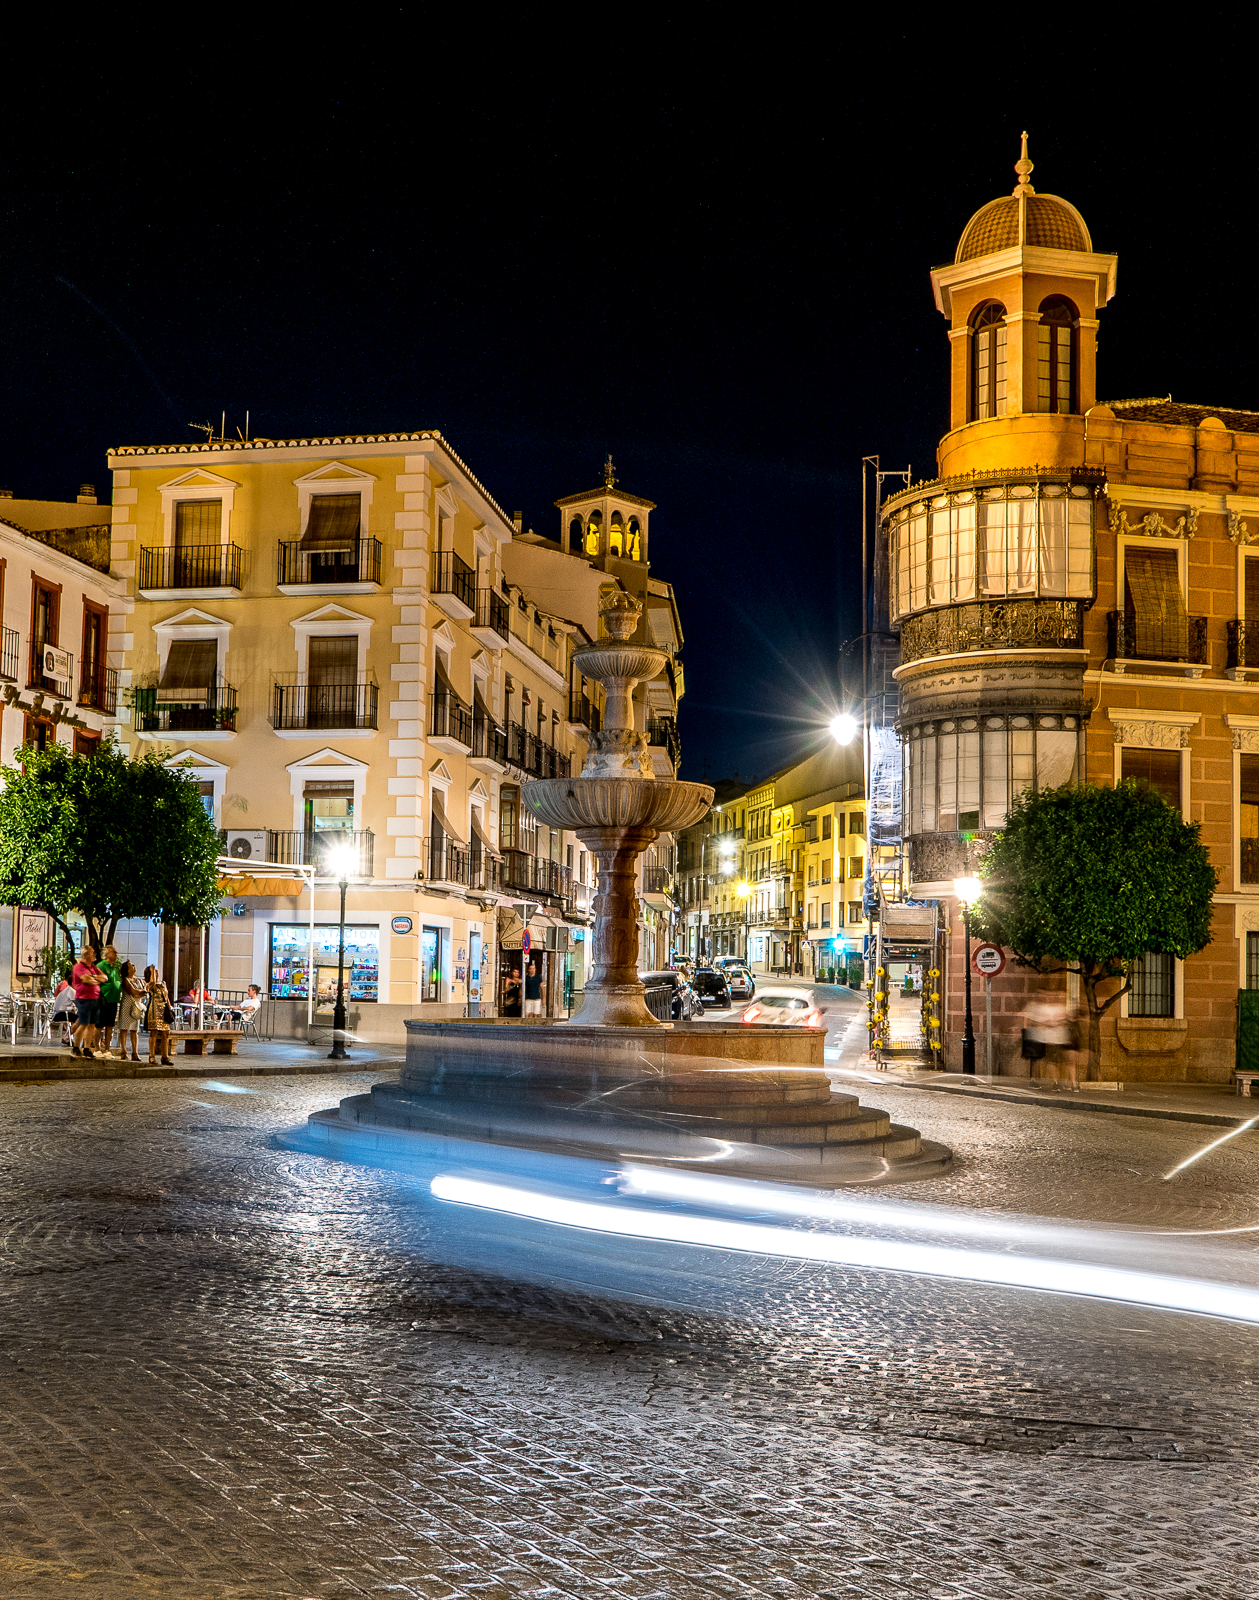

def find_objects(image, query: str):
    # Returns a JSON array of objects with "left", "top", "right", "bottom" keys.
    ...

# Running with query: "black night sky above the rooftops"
[{"left": 0, "top": 26, "right": 1259, "bottom": 778}]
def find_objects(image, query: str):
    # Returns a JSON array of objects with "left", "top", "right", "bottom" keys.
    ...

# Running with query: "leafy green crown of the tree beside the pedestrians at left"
[{"left": 0, "top": 744, "right": 221, "bottom": 950}]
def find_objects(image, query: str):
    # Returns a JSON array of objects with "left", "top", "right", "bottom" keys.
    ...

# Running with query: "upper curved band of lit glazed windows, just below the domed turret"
[{"left": 888, "top": 482, "right": 1094, "bottom": 619}]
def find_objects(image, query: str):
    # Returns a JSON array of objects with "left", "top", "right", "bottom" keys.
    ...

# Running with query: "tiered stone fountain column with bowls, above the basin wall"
[{"left": 523, "top": 590, "right": 712, "bottom": 1027}]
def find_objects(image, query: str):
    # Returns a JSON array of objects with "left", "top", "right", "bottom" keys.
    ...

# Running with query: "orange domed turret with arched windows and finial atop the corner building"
[{"left": 931, "top": 133, "right": 1118, "bottom": 477}]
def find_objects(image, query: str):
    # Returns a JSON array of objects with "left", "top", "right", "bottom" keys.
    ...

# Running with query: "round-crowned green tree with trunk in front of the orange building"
[{"left": 971, "top": 781, "right": 1219, "bottom": 1082}]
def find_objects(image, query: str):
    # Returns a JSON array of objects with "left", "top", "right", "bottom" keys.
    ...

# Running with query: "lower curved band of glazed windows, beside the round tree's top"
[{"left": 904, "top": 715, "right": 1080, "bottom": 835}]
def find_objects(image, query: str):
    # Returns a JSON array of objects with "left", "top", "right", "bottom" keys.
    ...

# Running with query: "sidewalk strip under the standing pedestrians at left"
[{"left": 0, "top": 1038, "right": 406, "bottom": 1085}]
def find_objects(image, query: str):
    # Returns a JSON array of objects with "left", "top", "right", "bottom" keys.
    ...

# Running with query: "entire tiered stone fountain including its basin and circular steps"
[{"left": 292, "top": 592, "right": 952, "bottom": 1186}]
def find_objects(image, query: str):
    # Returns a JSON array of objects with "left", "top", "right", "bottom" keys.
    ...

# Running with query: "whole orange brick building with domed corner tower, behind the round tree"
[{"left": 880, "top": 141, "right": 1259, "bottom": 1082}]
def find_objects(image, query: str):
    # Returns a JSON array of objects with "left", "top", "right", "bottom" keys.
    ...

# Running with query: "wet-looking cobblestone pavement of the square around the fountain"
[{"left": 0, "top": 1074, "right": 1259, "bottom": 1600}]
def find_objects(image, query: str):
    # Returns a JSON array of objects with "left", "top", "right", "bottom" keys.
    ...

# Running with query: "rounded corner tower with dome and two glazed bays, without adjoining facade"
[{"left": 880, "top": 134, "right": 1115, "bottom": 899}]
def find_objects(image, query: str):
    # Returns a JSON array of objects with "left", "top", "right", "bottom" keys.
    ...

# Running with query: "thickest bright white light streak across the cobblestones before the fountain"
[{"left": 430, "top": 1174, "right": 1259, "bottom": 1323}]
